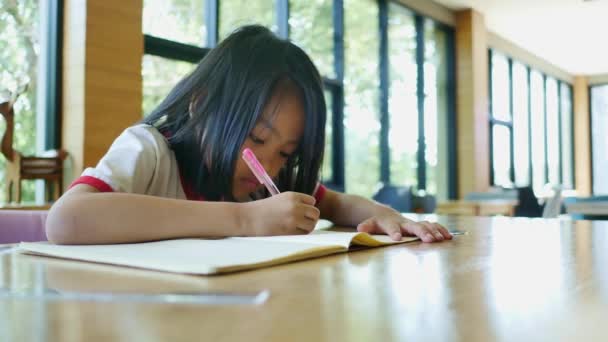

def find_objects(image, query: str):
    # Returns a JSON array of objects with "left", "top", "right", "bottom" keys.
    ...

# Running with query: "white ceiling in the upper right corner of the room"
[{"left": 435, "top": 0, "right": 608, "bottom": 75}]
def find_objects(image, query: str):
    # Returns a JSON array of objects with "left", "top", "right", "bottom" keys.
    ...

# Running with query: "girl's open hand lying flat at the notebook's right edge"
[{"left": 357, "top": 208, "right": 452, "bottom": 242}]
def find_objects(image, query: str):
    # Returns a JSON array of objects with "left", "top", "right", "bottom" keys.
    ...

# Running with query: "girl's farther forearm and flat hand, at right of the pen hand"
[{"left": 318, "top": 189, "right": 452, "bottom": 242}]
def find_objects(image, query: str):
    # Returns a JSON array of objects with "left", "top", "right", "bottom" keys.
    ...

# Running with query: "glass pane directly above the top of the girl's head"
[{"left": 219, "top": 0, "right": 277, "bottom": 40}]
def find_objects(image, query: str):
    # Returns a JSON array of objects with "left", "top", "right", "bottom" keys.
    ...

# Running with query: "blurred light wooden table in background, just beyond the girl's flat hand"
[{"left": 435, "top": 200, "right": 519, "bottom": 216}]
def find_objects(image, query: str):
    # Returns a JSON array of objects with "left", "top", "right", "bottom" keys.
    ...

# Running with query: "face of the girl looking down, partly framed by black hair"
[{"left": 232, "top": 90, "right": 305, "bottom": 201}]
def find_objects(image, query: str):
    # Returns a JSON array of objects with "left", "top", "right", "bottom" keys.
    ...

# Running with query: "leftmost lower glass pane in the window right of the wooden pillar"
[{"left": 492, "top": 125, "right": 511, "bottom": 186}]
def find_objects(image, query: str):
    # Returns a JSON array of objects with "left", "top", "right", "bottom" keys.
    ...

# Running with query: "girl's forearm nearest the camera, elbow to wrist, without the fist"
[{"left": 46, "top": 184, "right": 241, "bottom": 244}]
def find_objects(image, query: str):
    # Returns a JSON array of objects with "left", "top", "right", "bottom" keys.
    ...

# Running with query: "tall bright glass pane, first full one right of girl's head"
[{"left": 344, "top": 0, "right": 380, "bottom": 197}]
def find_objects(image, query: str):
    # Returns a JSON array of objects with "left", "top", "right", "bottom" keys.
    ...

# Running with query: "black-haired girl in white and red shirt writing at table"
[{"left": 46, "top": 26, "right": 452, "bottom": 244}]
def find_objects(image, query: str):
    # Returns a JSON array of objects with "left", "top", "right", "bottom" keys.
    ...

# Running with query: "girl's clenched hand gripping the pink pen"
[{"left": 242, "top": 192, "right": 320, "bottom": 236}]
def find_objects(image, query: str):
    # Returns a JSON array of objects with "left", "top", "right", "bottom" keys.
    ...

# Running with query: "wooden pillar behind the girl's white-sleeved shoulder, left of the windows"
[{"left": 62, "top": 0, "right": 143, "bottom": 184}]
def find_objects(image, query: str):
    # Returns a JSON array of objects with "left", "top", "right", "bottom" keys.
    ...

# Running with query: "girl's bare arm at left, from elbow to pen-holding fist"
[{"left": 46, "top": 184, "right": 319, "bottom": 244}]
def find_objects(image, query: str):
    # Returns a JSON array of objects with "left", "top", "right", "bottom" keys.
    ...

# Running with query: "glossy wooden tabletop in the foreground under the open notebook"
[{"left": 0, "top": 217, "right": 608, "bottom": 342}]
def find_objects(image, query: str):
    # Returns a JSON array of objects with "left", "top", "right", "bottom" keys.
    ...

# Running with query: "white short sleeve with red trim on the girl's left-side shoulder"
[{"left": 71, "top": 125, "right": 166, "bottom": 194}]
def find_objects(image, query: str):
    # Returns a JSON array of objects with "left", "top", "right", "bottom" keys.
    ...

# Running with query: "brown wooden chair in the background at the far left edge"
[{"left": 0, "top": 90, "right": 67, "bottom": 203}]
